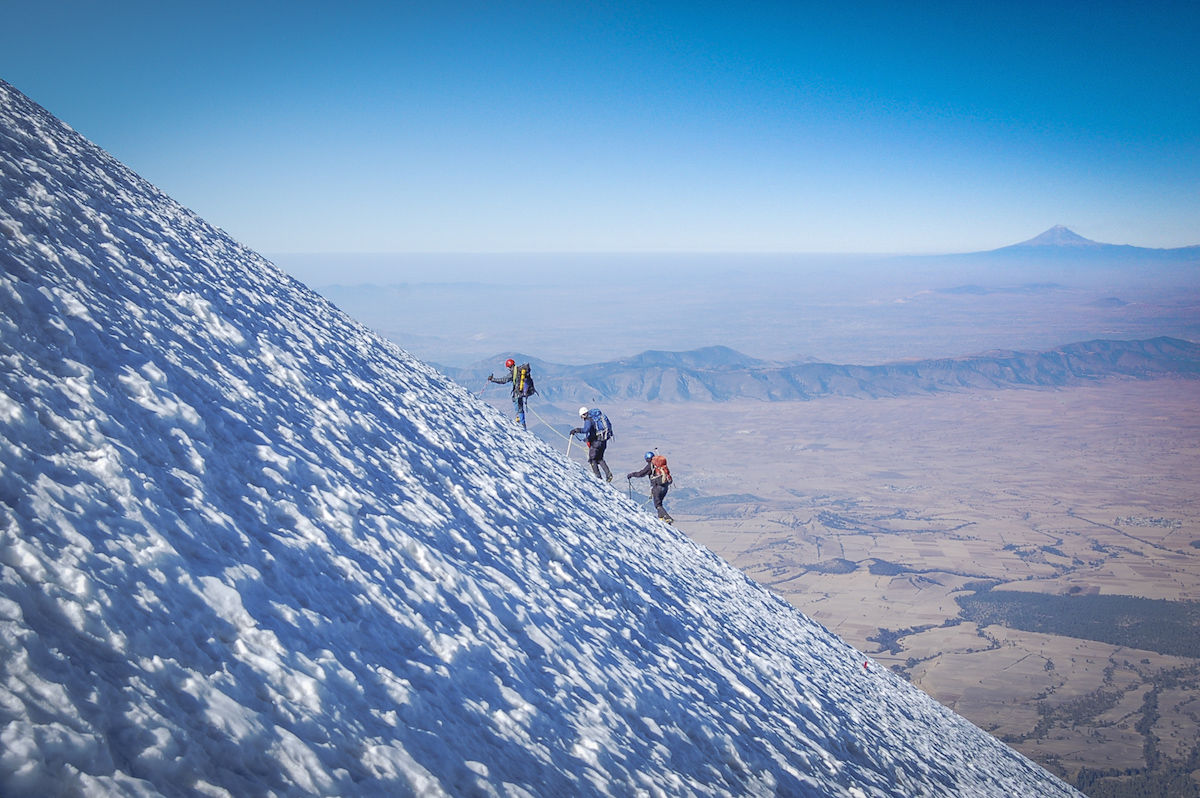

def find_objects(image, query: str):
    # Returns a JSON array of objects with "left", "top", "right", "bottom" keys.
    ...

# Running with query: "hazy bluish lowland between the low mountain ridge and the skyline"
[{"left": 275, "top": 253, "right": 1200, "bottom": 367}]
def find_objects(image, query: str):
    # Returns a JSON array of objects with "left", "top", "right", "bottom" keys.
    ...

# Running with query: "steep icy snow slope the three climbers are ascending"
[{"left": 0, "top": 83, "right": 1072, "bottom": 796}]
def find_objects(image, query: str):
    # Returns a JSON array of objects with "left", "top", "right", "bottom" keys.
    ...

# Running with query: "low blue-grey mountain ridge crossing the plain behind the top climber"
[{"left": 440, "top": 337, "right": 1200, "bottom": 403}]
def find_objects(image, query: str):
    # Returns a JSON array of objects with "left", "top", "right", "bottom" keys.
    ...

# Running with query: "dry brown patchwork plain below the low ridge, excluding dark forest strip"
[{"left": 573, "top": 380, "right": 1200, "bottom": 794}]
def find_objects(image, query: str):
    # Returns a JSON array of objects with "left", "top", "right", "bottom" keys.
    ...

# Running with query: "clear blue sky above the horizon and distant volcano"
[{"left": 0, "top": 0, "right": 1200, "bottom": 253}]
